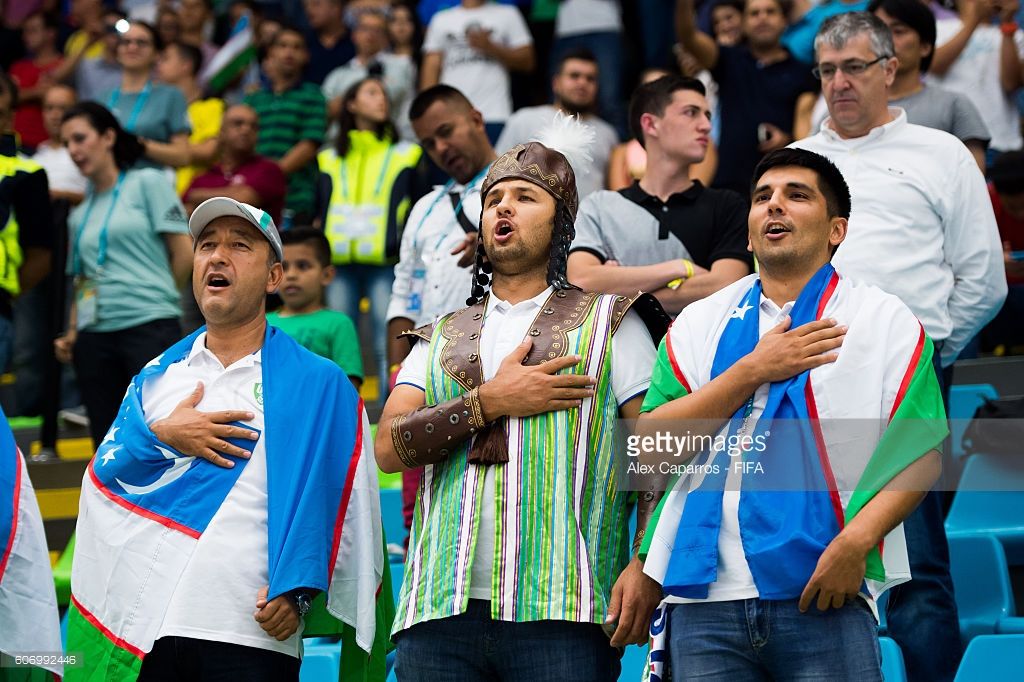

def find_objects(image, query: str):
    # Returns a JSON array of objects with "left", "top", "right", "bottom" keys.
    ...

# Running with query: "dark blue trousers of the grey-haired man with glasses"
[{"left": 886, "top": 344, "right": 963, "bottom": 682}]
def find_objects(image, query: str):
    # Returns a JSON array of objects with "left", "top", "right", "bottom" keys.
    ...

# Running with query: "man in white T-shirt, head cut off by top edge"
[{"left": 420, "top": 0, "right": 535, "bottom": 124}]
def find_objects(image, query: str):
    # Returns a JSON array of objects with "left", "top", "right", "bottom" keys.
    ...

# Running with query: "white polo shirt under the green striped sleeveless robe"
[{"left": 396, "top": 287, "right": 657, "bottom": 601}]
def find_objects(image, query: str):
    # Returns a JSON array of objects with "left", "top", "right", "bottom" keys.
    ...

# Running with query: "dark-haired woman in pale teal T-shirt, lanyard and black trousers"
[{"left": 54, "top": 101, "right": 193, "bottom": 445}]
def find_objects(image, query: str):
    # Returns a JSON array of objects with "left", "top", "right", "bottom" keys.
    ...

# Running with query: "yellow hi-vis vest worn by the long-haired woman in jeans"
[{"left": 316, "top": 130, "right": 423, "bottom": 265}]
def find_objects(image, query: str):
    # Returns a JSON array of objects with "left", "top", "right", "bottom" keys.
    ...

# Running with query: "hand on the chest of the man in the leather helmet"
[{"left": 480, "top": 339, "right": 597, "bottom": 422}]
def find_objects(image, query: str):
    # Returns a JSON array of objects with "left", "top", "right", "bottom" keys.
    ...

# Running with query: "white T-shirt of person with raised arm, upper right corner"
[{"left": 928, "top": 17, "right": 1024, "bottom": 152}]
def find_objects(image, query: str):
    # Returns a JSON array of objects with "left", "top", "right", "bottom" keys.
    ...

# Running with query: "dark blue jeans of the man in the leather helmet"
[{"left": 394, "top": 599, "right": 622, "bottom": 682}]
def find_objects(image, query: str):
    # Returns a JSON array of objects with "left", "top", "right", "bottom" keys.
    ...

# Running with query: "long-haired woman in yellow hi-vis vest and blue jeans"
[{"left": 317, "top": 78, "right": 422, "bottom": 394}]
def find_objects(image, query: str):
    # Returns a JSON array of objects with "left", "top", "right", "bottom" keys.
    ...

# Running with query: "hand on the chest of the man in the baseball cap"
[{"left": 150, "top": 382, "right": 259, "bottom": 469}]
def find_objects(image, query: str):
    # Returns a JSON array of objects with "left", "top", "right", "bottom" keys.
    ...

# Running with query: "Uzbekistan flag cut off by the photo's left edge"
[{"left": 0, "top": 403, "right": 62, "bottom": 678}]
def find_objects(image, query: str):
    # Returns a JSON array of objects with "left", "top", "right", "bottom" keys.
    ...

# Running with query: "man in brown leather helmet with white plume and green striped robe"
[{"left": 376, "top": 118, "right": 669, "bottom": 681}]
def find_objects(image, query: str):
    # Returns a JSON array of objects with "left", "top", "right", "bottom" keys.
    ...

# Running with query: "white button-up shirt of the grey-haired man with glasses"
[{"left": 790, "top": 108, "right": 1007, "bottom": 366}]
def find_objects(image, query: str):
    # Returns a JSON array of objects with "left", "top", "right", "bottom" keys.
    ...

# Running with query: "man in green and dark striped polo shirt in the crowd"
[{"left": 246, "top": 26, "right": 327, "bottom": 223}]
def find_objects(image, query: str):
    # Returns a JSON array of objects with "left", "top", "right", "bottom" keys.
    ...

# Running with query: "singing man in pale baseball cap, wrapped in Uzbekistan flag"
[{"left": 69, "top": 197, "right": 390, "bottom": 682}]
